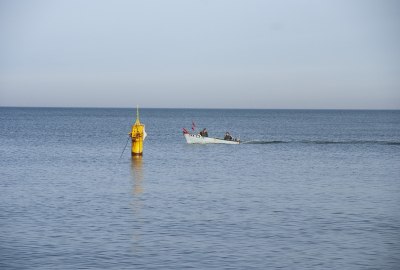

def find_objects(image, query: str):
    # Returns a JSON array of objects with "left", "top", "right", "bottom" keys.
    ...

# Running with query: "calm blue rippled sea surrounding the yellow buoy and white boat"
[{"left": 0, "top": 108, "right": 400, "bottom": 269}]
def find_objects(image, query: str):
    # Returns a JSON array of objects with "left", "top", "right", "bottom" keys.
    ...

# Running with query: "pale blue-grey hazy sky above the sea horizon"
[{"left": 0, "top": 0, "right": 400, "bottom": 110}]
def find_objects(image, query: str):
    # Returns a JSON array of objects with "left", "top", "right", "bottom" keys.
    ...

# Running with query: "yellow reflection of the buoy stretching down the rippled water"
[{"left": 130, "top": 156, "right": 143, "bottom": 252}]
